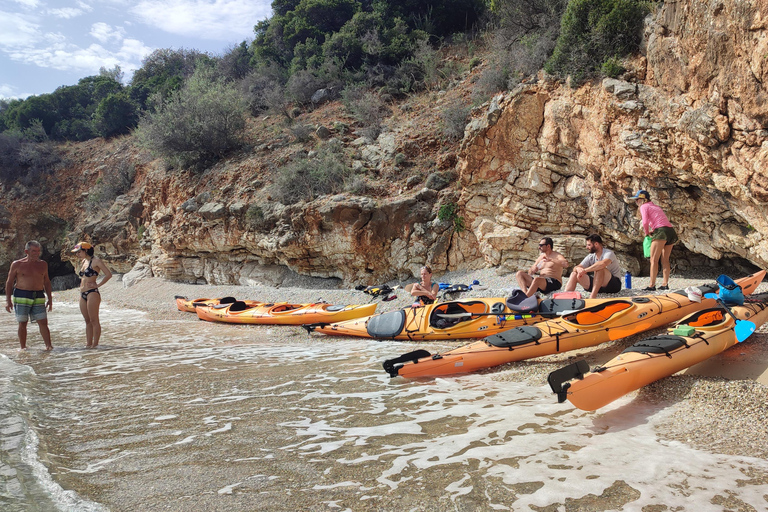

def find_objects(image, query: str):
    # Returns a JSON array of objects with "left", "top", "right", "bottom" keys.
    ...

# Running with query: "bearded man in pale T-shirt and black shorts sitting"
[{"left": 565, "top": 234, "right": 622, "bottom": 299}]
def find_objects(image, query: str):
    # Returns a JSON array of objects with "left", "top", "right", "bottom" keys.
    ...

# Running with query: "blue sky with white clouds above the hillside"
[{"left": 0, "top": 0, "right": 272, "bottom": 98}]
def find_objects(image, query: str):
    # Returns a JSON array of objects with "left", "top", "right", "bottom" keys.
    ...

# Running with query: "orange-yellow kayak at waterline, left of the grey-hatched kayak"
[{"left": 195, "top": 301, "right": 376, "bottom": 325}]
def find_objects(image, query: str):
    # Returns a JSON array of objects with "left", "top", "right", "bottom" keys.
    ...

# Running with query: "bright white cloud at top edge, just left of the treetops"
[{"left": 131, "top": 0, "right": 272, "bottom": 41}]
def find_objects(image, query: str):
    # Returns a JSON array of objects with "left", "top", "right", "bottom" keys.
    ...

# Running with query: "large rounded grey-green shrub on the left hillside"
[{"left": 135, "top": 66, "right": 247, "bottom": 169}]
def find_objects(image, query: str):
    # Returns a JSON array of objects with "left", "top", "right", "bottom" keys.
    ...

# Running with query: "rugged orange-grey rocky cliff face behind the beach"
[{"left": 0, "top": 0, "right": 768, "bottom": 284}]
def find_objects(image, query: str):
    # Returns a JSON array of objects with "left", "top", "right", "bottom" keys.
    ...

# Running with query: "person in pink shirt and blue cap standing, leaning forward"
[{"left": 630, "top": 190, "right": 678, "bottom": 291}]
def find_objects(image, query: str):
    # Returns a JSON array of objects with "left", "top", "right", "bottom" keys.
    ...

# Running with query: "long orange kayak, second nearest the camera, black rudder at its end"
[{"left": 383, "top": 271, "right": 765, "bottom": 378}]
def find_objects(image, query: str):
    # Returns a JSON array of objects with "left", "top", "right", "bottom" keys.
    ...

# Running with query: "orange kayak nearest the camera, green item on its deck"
[{"left": 548, "top": 294, "right": 768, "bottom": 411}]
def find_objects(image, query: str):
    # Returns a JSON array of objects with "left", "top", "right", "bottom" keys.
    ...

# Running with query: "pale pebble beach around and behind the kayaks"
[{"left": 54, "top": 269, "right": 768, "bottom": 459}]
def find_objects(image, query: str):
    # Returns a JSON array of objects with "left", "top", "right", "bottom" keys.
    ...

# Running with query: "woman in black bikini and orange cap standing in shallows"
[{"left": 72, "top": 242, "right": 112, "bottom": 348}]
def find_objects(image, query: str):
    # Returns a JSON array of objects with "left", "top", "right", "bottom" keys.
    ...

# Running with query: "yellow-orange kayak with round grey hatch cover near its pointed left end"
[{"left": 314, "top": 297, "right": 592, "bottom": 341}]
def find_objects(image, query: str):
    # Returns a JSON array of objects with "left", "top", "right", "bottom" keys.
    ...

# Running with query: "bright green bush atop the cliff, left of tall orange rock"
[{"left": 545, "top": 0, "right": 648, "bottom": 85}]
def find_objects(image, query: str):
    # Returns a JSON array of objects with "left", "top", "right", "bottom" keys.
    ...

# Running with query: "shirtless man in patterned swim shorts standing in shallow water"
[{"left": 5, "top": 240, "right": 53, "bottom": 350}]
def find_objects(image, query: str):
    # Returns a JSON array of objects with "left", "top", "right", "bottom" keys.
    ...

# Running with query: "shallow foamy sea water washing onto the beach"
[{"left": 0, "top": 303, "right": 768, "bottom": 512}]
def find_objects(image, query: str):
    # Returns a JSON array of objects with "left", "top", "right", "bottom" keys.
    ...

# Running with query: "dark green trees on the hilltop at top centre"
[{"left": 251, "top": 0, "right": 485, "bottom": 73}]
